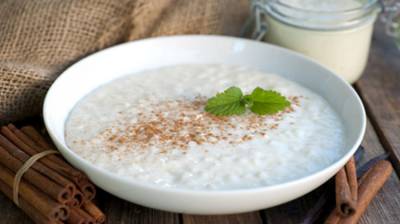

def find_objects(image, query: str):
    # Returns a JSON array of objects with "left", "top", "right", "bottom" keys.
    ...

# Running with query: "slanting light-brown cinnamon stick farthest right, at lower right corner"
[{"left": 341, "top": 160, "right": 393, "bottom": 224}]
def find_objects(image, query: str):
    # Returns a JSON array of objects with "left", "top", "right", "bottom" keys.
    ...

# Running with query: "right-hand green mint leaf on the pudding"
[{"left": 249, "top": 87, "right": 290, "bottom": 115}]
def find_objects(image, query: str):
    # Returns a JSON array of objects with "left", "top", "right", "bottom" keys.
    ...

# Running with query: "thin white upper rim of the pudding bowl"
[{"left": 43, "top": 35, "right": 366, "bottom": 196}]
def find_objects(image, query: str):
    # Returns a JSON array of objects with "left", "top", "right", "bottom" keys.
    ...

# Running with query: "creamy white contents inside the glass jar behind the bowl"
[{"left": 266, "top": 0, "right": 375, "bottom": 83}]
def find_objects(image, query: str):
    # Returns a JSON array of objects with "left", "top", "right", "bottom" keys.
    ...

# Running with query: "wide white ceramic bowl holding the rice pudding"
[{"left": 43, "top": 35, "right": 366, "bottom": 214}]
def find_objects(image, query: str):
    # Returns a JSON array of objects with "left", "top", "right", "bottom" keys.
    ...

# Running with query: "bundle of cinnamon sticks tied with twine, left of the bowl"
[{"left": 0, "top": 124, "right": 105, "bottom": 224}]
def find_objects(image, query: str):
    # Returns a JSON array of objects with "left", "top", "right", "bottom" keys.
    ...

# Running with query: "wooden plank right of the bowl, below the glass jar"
[{"left": 356, "top": 23, "right": 400, "bottom": 174}]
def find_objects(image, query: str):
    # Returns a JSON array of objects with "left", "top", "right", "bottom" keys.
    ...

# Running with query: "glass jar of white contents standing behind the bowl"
[{"left": 247, "top": 0, "right": 381, "bottom": 83}]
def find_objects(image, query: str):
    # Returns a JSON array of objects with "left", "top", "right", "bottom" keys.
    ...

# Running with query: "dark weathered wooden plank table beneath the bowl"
[{"left": 0, "top": 24, "right": 400, "bottom": 224}]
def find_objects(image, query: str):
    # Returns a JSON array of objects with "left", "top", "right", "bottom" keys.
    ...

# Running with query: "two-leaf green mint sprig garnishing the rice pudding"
[{"left": 205, "top": 86, "right": 290, "bottom": 116}]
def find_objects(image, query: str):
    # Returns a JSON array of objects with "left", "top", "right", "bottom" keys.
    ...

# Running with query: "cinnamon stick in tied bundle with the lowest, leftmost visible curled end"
[{"left": 0, "top": 165, "right": 69, "bottom": 220}]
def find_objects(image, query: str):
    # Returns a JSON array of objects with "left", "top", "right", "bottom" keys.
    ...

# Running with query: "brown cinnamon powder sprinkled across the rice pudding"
[{"left": 100, "top": 96, "right": 301, "bottom": 153}]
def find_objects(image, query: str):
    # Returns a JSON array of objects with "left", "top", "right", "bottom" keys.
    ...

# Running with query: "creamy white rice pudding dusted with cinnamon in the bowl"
[{"left": 66, "top": 65, "right": 345, "bottom": 190}]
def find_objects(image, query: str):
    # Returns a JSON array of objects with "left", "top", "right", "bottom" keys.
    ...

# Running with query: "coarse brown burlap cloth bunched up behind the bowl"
[{"left": 0, "top": 0, "right": 249, "bottom": 123}]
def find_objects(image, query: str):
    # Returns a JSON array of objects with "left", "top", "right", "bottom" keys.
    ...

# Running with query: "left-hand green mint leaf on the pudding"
[{"left": 205, "top": 87, "right": 246, "bottom": 116}]
